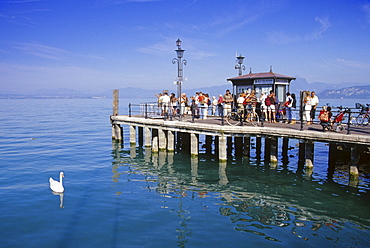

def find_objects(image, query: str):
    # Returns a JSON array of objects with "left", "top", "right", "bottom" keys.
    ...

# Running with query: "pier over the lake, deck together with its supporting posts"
[{"left": 110, "top": 90, "right": 370, "bottom": 185}]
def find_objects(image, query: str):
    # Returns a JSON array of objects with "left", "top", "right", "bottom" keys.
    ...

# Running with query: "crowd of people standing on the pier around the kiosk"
[{"left": 156, "top": 90, "right": 319, "bottom": 125}]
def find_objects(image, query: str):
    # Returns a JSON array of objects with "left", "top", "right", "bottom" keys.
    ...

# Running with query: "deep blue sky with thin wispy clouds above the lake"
[{"left": 0, "top": 0, "right": 370, "bottom": 92}]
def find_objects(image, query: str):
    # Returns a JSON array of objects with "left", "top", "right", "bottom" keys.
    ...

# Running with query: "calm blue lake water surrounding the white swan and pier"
[{"left": 0, "top": 99, "right": 370, "bottom": 247}]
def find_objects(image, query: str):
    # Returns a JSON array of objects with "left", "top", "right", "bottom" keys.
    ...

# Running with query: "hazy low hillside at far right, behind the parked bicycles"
[{"left": 318, "top": 85, "right": 370, "bottom": 99}]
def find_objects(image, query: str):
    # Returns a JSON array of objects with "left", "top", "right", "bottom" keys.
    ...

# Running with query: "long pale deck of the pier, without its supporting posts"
[{"left": 111, "top": 115, "right": 370, "bottom": 146}]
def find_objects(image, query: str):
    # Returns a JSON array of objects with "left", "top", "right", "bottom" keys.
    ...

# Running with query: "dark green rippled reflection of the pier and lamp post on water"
[{"left": 112, "top": 143, "right": 370, "bottom": 247}]
